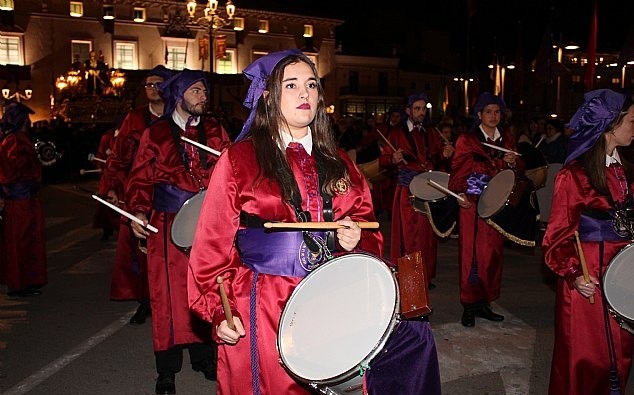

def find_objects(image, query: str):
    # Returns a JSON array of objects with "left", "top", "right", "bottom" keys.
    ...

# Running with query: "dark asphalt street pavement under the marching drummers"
[{"left": 0, "top": 177, "right": 634, "bottom": 395}]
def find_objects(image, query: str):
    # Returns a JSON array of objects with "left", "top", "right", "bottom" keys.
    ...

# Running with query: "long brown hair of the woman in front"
[{"left": 250, "top": 54, "right": 350, "bottom": 201}]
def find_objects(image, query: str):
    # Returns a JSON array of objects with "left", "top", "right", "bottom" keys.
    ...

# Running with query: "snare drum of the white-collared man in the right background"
[{"left": 478, "top": 169, "right": 539, "bottom": 247}]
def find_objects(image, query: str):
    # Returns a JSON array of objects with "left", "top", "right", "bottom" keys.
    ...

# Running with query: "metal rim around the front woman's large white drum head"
[{"left": 276, "top": 252, "right": 400, "bottom": 385}]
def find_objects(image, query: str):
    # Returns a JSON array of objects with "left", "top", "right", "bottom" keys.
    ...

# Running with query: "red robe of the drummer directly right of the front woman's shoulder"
[{"left": 381, "top": 124, "right": 443, "bottom": 280}]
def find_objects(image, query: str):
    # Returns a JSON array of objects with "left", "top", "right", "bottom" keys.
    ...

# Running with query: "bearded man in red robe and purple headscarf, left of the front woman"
[{"left": 125, "top": 69, "right": 230, "bottom": 394}]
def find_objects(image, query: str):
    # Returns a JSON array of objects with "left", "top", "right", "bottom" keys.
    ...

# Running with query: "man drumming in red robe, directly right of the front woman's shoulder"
[{"left": 380, "top": 93, "right": 454, "bottom": 288}]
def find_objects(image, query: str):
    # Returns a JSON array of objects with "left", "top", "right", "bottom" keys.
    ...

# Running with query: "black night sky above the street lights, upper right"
[{"left": 234, "top": 0, "right": 634, "bottom": 72}]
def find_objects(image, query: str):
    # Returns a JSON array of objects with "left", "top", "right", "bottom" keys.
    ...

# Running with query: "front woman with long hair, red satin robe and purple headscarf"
[{"left": 188, "top": 49, "right": 440, "bottom": 395}]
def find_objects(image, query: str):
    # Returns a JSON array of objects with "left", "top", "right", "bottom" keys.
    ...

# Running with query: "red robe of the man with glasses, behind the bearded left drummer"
[{"left": 103, "top": 105, "right": 157, "bottom": 300}]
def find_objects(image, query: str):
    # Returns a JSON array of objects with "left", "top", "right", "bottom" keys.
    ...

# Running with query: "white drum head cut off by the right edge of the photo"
[{"left": 602, "top": 244, "right": 634, "bottom": 322}]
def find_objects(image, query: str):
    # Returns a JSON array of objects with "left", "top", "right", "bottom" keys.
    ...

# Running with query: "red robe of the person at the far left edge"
[{"left": 0, "top": 132, "right": 47, "bottom": 290}]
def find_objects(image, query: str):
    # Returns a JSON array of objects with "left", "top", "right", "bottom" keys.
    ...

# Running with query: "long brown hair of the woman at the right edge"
[{"left": 578, "top": 96, "right": 634, "bottom": 196}]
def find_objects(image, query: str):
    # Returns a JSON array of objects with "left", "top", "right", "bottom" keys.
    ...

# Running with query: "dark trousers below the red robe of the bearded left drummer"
[{"left": 154, "top": 343, "right": 218, "bottom": 374}]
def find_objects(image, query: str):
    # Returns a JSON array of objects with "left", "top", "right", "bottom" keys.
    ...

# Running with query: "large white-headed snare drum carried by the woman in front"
[{"left": 277, "top": 253, "right": 400, "bottom": 395}]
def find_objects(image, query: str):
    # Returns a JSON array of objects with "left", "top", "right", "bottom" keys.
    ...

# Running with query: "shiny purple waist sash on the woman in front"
[{"left": 237, "top": 228, "right": 326, "bottom": 277}]
